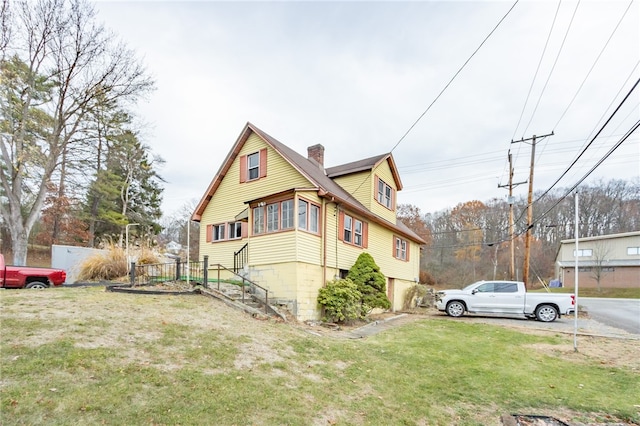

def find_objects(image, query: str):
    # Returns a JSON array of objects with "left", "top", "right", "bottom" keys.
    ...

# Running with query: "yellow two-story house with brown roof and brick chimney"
[{"left": 192, "top": 123, "right": 424, "bottom": 320}]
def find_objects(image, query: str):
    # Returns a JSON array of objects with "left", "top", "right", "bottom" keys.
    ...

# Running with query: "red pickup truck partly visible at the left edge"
[{"left": 0, "top": 254, "right": 67, "bottom": 288}]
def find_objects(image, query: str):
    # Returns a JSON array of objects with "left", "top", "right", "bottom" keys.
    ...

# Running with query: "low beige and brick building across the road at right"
[{"left": 556, "top": 231, "right": 640, "bottom": 288}]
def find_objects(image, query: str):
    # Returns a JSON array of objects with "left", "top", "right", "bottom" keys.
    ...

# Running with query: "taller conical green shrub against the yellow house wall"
[{"left": 347, "top": 253, "right": 391, "bottom": 314}]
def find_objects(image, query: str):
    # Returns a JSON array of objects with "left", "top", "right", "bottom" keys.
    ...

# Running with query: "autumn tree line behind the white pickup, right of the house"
[{"left": 398, "top": 178, "right": 640, "bottom": 287}]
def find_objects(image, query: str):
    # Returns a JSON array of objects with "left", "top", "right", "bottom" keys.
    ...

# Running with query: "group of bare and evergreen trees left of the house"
[{"left": 0, "top": 0, "right": 163, "bottom": 265}]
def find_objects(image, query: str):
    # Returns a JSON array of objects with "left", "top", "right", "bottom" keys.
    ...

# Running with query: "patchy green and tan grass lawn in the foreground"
[{"left": 0, "top": 288, "right": 640, "bottom": 425}]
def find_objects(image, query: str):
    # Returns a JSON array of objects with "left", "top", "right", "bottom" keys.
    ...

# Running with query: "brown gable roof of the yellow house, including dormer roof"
[{"left": 191, "top": 123, "right": 425, "bottom": 244}]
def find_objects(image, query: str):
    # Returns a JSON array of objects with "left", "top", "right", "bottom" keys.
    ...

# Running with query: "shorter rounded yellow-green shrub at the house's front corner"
[{"left": 318, "top": 279, "right": 362, "bottom": 322}]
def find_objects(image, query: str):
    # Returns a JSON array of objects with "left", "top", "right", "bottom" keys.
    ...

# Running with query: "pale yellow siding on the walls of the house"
[{"left": 200, "top": 129, "right": 420, "bottom": 320}]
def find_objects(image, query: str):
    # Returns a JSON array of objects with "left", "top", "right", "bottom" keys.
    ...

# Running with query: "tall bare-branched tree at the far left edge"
[{"left": 0, "top": 0, "right": 153, "bottom": 265}]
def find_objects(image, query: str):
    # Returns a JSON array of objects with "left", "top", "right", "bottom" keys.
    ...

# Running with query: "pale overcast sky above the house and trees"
[{"left": 96, "top": 0, "right": 640, "bottom": 220}]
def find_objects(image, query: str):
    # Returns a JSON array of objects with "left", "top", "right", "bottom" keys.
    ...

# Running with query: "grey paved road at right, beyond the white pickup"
[{"left": 578, "top": 297, "right": 640, "bottom": 334}]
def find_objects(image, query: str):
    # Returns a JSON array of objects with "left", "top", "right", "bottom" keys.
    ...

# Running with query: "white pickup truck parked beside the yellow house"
[{"left": 436, "top": 281, "right": 575, "bottom": 322}]
